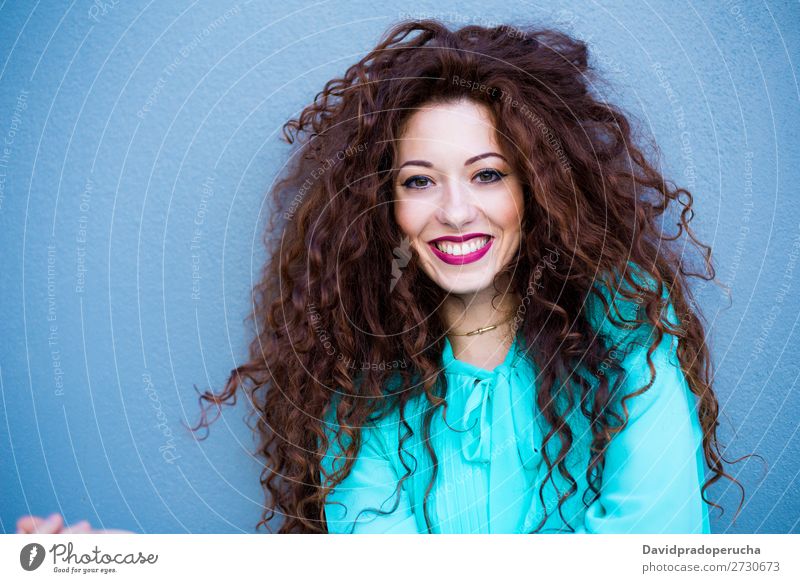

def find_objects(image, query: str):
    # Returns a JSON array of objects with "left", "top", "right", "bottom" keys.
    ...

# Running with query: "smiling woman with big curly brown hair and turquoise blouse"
[{"left": 17, "top": 20, "right": 741, "bottom": 533}]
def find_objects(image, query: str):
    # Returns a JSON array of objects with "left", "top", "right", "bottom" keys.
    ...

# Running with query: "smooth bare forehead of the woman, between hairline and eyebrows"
[{"left": 397, "top": 100, "right": 499, "bottom": 158}]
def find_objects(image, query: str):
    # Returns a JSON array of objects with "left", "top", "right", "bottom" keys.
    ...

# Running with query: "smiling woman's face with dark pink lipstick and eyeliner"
[{"left": 394, "top": 100, "right": 523, "bottom": 294}]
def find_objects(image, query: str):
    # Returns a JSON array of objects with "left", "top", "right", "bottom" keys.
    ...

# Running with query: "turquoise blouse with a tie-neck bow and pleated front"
[{"left": 322, "top": 276, "right": 710, "bottom": 533}]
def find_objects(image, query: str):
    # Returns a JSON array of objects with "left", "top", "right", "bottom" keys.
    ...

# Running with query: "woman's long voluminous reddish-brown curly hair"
[{"left": 193, "top": 19, "right": 744, "bottom": 533}]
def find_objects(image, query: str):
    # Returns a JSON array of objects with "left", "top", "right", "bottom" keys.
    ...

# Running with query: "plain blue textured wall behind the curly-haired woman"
[{"left": 0, "top": 0, "right": 800, "bottom": 532}]
